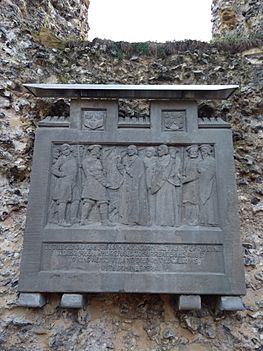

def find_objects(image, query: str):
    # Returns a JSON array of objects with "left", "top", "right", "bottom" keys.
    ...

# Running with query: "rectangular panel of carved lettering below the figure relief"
[{"left": 42, "top": 243, "right": 224, "bottom": 273}]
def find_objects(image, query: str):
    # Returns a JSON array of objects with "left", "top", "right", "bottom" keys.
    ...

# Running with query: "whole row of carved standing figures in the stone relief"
[{"left": 48, "top": 144, "right": 218, "bottom": 227}]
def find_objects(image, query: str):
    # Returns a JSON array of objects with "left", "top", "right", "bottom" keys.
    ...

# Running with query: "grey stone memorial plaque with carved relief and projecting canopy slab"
[{"left": 19, "top": 84, "right": 245, "bottom": 300}]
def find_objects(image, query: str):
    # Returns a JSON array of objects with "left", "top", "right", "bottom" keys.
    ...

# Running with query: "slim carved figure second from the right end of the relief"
[{"left": 182, "top": 145, "right": 200, "bottom": 225}]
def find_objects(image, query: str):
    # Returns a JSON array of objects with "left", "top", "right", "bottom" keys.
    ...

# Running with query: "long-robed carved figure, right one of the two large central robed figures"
[{"left": 152, "top": 145, "right": 180, "bottom": 226}]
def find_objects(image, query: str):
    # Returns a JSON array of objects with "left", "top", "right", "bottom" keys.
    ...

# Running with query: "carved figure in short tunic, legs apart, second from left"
[{"left": 80, "top": 145, "right": 112, "bottom": 225}]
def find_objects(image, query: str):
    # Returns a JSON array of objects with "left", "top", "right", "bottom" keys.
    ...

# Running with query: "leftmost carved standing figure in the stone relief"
[{"left": 51, "top": 144, "right": 77, "bottom": 226}]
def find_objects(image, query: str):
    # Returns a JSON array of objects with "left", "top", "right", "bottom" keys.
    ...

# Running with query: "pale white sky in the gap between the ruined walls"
[{"left": 88, "top": 0, "right": 212, "bottom": 42}]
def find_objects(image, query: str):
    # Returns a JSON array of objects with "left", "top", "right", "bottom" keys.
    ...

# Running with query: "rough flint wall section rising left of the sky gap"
[{"left": 0, "top": 0, "right": 90, "bottom": 45}]
